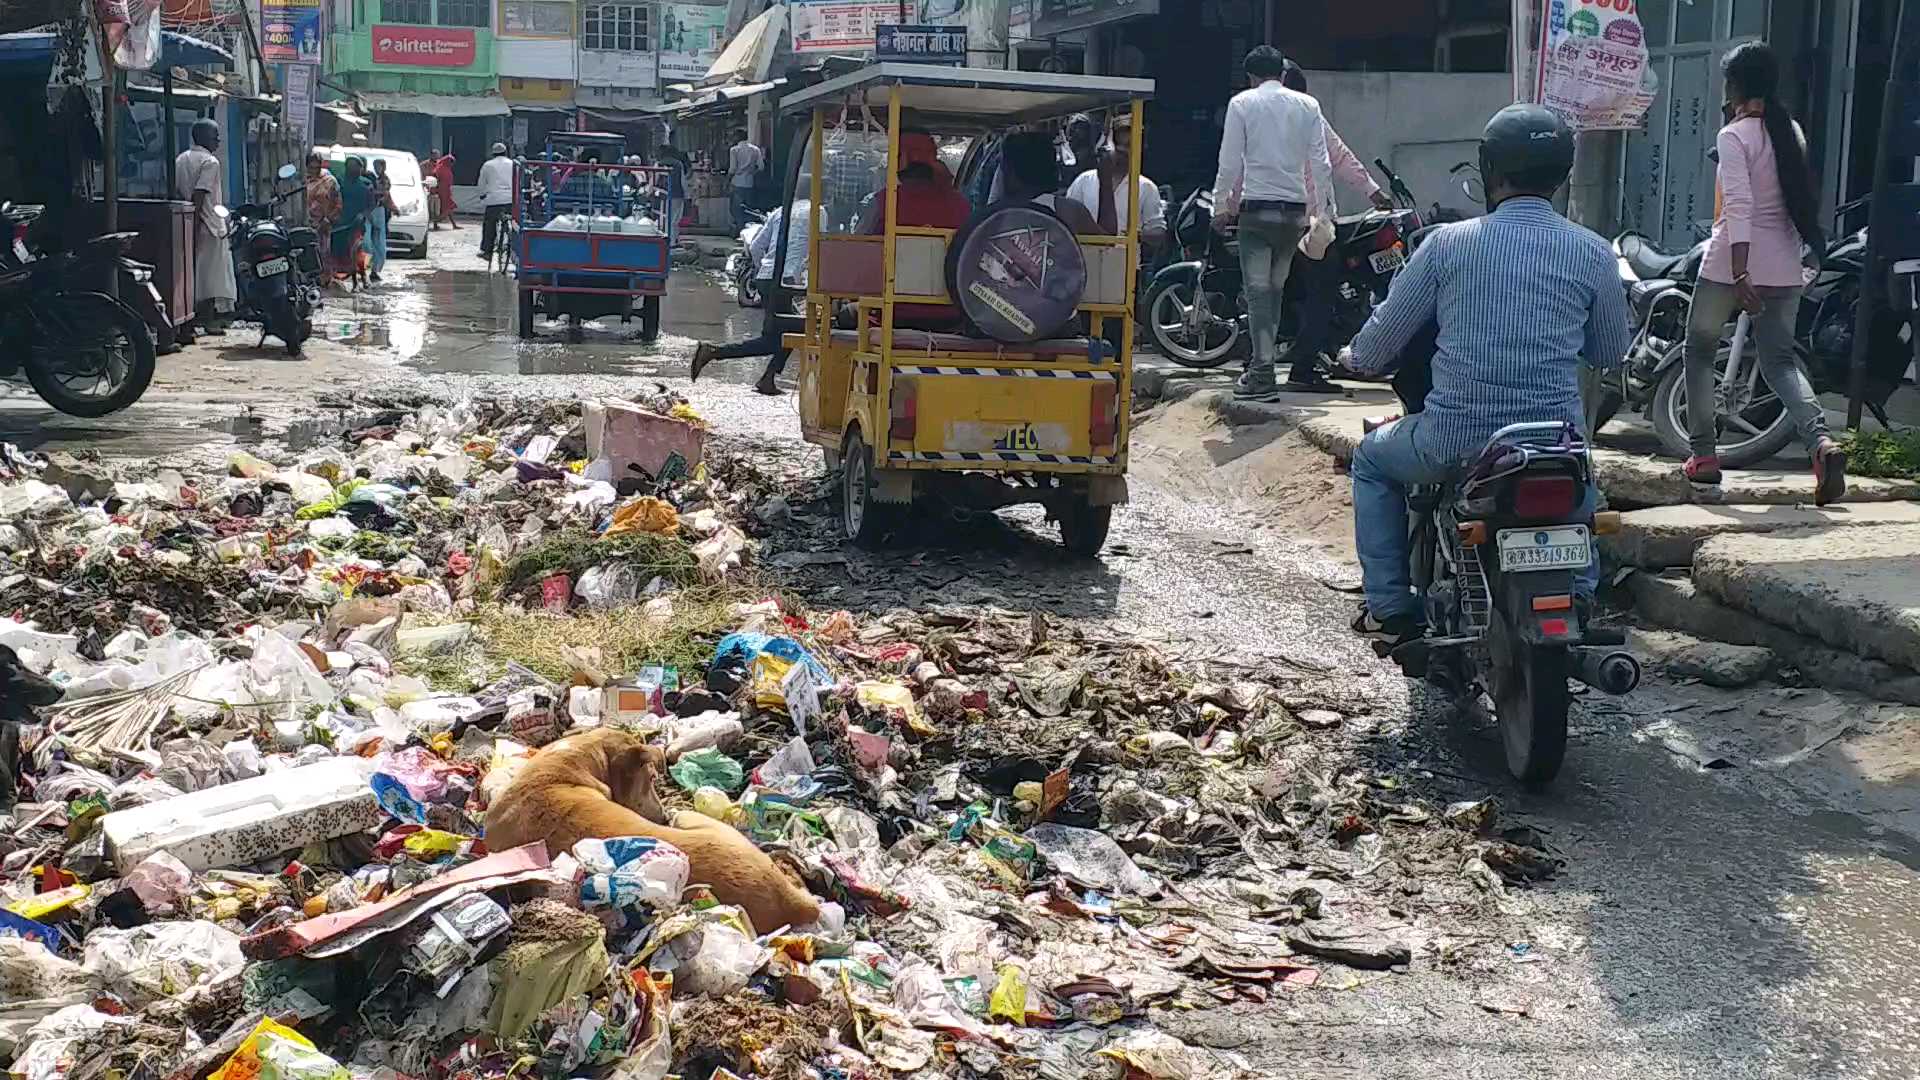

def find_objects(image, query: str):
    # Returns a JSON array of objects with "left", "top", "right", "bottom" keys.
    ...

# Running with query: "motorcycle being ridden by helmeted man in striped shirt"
[{"left": 1365, "top": 331, "right": 1640, "bottom": 784}]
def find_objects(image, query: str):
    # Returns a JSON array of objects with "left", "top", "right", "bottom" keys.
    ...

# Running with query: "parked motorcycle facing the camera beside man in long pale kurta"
[{"left": 215, "top": 165, "right": 321, "bottom": 356}]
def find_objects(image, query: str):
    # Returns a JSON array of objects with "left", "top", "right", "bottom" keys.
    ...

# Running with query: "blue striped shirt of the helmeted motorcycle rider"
[{"left": 1352, "top": 196, "right": 1634, "bottom": 461}]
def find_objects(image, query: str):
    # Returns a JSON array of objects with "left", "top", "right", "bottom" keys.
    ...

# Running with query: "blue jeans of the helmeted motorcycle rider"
[{"left": 1352, "top": 413, "right": 1599, "bottom": 621}]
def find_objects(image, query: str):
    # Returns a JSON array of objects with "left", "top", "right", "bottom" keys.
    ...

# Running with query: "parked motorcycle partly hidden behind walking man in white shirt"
[{"left": 1142, "top": 160, "right": 1421, "bottom": 369}]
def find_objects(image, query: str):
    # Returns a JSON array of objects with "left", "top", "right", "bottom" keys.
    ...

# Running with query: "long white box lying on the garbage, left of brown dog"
[{"left": 100, "top": 757, "right": 386, "bottom": 874}]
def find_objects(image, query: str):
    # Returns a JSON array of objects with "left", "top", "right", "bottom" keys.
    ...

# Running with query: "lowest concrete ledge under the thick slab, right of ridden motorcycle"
[{"left": 1626, "top": 573, "right": 1920, "bottom": 705}]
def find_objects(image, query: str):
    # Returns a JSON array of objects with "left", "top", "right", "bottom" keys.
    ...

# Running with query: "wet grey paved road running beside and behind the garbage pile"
[{"left": 0, "top": 231, "right": 1920, "bottom": 1078}]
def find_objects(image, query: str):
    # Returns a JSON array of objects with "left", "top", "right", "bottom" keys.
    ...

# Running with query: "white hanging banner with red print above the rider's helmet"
[{"left": 1513, "top": 0, "right": 1659, "bottom": 131}]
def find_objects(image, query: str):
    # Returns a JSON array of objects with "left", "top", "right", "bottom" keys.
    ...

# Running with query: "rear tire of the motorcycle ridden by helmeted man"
[{"left": 1486, "top": 603, "right": 1567, "bottom": 786}]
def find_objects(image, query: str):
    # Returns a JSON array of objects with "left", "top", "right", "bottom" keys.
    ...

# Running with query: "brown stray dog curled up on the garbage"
[{"left": 486, "top": 728, "right": 820, "bottom": 934}]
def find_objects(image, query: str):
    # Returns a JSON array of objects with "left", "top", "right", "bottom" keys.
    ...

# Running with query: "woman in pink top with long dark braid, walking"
[{"left": 1684, "top": 42, "right": 1847, "bottom": 503}]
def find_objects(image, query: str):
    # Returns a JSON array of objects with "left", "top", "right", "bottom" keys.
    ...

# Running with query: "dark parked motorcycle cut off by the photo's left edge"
[{"left": 0, "top": 204, "right": 156, "bottom": 417}]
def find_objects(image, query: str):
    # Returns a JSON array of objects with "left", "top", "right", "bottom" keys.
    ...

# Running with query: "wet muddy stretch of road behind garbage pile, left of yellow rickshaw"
[{"left": 0, "top": 237, "right": 760, "bottom": 461}]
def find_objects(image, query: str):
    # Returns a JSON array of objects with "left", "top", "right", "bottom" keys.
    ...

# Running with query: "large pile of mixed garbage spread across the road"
[{"left": 0, "top": 396, "right": 1559, "bottom": 1080}]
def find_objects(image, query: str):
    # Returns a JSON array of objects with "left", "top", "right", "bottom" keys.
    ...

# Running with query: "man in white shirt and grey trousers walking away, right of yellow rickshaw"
[{"left": 1213, "top": 44, "right": 1332, "bottom": 400}]
